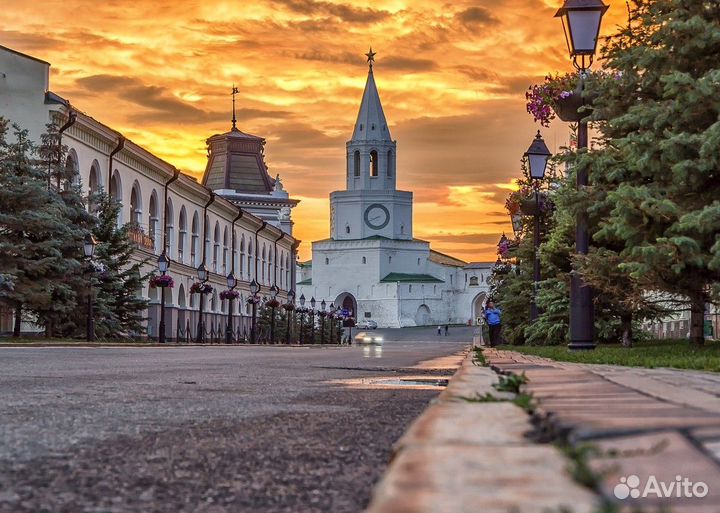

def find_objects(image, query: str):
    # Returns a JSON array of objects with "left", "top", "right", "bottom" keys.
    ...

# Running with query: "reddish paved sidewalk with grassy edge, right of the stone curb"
[{"left": 486, "top": 350, "right": 720, "bottom": 513}]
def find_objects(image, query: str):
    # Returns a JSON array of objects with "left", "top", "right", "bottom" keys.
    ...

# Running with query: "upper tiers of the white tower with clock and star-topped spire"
[{"left": 330, "top": 48, "right": 412, "bottom": 240}]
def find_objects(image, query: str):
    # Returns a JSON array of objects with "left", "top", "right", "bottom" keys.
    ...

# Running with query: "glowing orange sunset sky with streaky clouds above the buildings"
[{"left": 0, "top": 0, "right": 626, "bottom": 261}]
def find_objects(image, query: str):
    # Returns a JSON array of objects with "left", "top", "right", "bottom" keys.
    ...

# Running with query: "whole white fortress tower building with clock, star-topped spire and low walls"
[{"left": 297, "top": 57, "right": 494, "bottom": 327}]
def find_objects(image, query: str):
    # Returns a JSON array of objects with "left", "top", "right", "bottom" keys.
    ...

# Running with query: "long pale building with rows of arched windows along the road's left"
[{"left": 0, "top": 47, "right": 299, "bottom": 339}]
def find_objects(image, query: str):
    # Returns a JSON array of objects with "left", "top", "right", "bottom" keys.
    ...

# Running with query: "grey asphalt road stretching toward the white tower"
[{"left": 0, "top": 328, "right": 471, "bottom": 513}]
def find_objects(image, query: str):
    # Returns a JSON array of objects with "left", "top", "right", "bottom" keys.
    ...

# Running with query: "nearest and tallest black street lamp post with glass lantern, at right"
[{"left": 555, "top": 0, "right": 608, "bottom": 350}]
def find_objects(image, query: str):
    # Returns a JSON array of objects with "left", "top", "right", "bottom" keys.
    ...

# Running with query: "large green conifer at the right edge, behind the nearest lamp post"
[{"left": 578, "top": 0, "right": 720, "bottom": 344}]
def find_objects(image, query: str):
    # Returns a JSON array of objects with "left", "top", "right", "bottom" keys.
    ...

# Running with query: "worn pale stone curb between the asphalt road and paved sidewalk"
[{"left": 365, "top": 352, "right": 598, "bottom": 513}]
